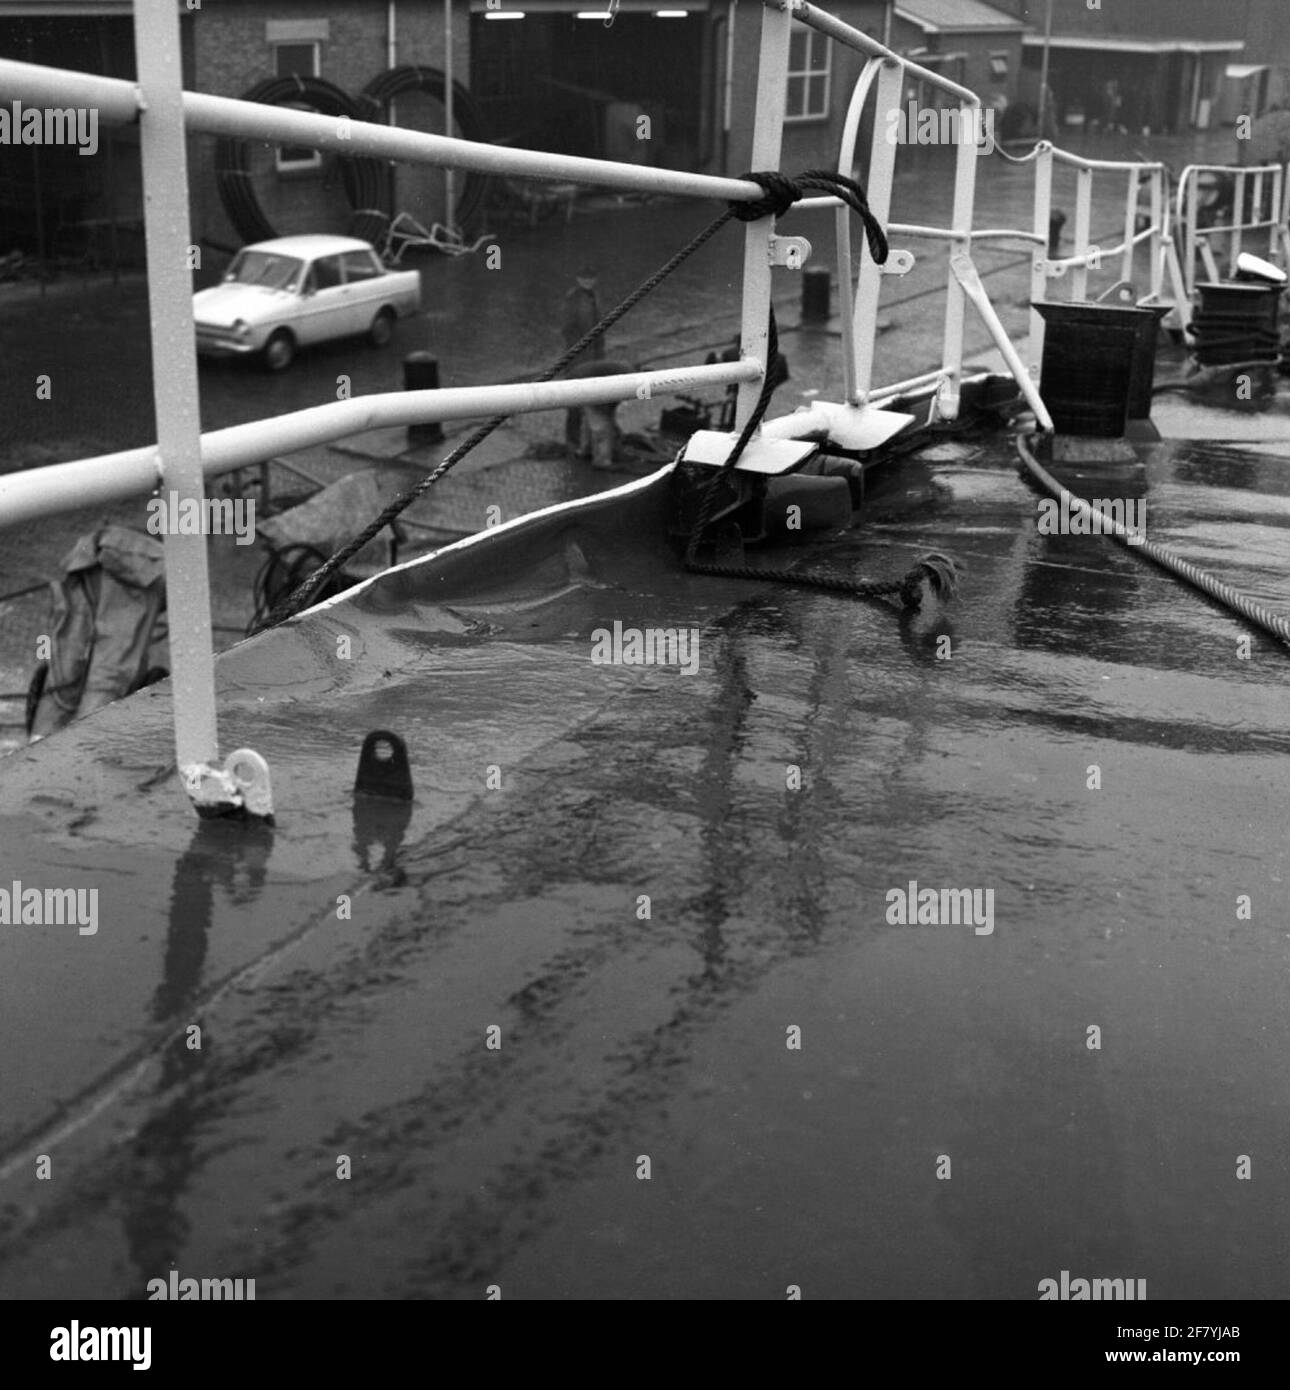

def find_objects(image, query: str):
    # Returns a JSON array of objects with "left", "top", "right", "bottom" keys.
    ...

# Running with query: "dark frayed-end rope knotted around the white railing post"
[{"left": 256, "top": 170, "right": 958, "bottom": 631}]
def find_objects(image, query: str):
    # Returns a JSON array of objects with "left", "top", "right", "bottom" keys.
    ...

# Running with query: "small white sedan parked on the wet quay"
[{"left": 193, "top": 236, "right": 421, "bottom": 371}]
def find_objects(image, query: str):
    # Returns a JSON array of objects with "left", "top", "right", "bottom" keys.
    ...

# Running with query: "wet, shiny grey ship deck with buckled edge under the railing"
[{"left": 0, "top": 419, "right": 1290, "bottom": 1300}]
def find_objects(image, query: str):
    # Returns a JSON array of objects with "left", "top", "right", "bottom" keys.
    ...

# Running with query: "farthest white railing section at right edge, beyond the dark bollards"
[{"left": 1176, "top": 164, "right": 1290, "bottom": 296}]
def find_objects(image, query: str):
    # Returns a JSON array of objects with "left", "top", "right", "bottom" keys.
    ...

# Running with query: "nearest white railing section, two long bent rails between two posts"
[{"left": 0, "top": 0, "right": 790, "bottom": 813}]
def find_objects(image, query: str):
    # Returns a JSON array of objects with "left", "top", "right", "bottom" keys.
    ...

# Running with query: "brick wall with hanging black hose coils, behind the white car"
[{"left": 185, "top": 0, "right": 470, "bottom": 258}]
